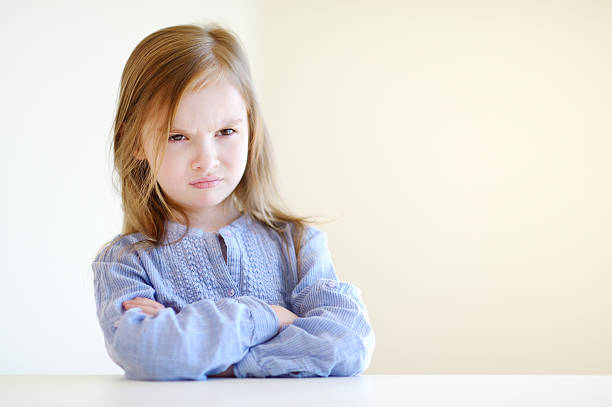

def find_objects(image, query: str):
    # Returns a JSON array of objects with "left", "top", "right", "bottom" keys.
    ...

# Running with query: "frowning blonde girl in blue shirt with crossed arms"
[{"left": 92, "top": 25, "right": 375, "bottom": 380}]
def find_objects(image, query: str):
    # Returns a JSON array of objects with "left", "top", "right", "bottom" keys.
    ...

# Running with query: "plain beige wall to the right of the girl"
[{"left": 259, "top": 0, "right": 612, "bottom": 373}]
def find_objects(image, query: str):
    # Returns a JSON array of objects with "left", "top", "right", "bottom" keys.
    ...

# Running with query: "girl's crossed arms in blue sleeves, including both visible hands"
[{"left": 92, "top": 228, "right": 375, "bottom": 380}]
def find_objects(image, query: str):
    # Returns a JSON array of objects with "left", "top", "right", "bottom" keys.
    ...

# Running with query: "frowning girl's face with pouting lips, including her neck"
[{"left": 145, "top": 79, "right": 249, "bottom": 229}]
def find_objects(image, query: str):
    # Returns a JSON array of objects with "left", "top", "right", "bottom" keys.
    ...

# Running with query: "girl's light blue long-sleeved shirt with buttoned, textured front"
[{"left": 92, "top": 214, "right": 375, "bottom": 380}]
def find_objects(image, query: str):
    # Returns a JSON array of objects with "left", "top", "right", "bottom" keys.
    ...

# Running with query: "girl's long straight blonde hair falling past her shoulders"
[{"left": 100, "top": 24, "right": 320, "bottom": 276}]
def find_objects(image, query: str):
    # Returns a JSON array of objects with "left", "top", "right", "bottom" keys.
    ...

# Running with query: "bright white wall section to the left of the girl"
[{"left": 0, "top": 0, "right": 258, "bottom": 374}]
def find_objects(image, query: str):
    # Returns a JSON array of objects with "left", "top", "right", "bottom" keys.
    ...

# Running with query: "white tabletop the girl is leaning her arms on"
[{"left": 0, "top": 375, "right": 612, "bottom": 407}]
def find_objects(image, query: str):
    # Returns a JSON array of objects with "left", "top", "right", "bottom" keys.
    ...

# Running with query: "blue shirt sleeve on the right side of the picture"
[{"left": 234, "top": 227, "right": 375, "bottom": 377}]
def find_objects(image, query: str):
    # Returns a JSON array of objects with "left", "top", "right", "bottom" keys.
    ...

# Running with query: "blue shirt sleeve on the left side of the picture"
[{"left": 92, "top": 236, "right": 279, "bottom": 380}]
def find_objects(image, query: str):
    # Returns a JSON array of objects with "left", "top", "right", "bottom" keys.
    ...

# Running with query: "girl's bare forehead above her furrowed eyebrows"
[{"left": 172, "top": 79, "right": 246, "bottom": 131}]
